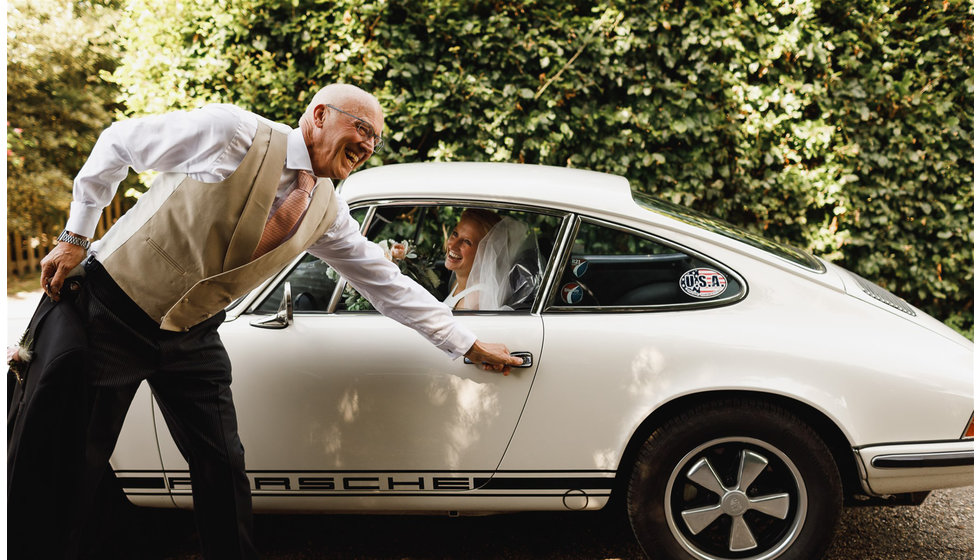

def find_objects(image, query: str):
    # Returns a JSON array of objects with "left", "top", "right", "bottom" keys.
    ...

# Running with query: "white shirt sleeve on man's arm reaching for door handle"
[{"left": 308, "top": 201, "right": 476, "bottom": 358}]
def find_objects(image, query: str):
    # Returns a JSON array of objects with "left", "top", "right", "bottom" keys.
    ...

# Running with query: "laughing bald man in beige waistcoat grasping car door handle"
[{"left": 28, "top": 84, "right": 520, "bottom": 559}]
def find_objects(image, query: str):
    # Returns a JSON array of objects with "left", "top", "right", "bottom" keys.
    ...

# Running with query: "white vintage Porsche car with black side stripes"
[{"left": 112, "top": 163, "right": 974, "bottom": 560}]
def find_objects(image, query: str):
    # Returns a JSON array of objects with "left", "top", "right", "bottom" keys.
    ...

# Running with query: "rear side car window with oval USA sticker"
[{"left": 551, "top": 220, "right": 743, "bottom": 310}]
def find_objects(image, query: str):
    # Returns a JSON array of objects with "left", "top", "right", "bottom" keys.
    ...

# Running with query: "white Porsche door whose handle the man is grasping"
[{"left": 156, "top": 205, "right": 560, "bottom": 510}]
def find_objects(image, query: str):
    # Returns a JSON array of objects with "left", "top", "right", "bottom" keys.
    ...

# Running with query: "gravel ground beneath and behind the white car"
[{"left": 91, "top": 487, "right": 974, "bottom": 560}]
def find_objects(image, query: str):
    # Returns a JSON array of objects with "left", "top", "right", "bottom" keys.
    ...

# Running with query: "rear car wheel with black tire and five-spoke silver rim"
[{"left": 626, "top": 400, "right": 842, "bottom": 560}]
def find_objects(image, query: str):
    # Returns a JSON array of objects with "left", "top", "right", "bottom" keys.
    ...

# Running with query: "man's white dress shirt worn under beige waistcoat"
[{"left": 65, "top": 105, "right": 476, "bottom": 358}]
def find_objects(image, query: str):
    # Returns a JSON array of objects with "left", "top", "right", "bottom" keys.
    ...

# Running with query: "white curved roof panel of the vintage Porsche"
[{"left": 341, "top": 162, "right": 637, "bottom": 215}]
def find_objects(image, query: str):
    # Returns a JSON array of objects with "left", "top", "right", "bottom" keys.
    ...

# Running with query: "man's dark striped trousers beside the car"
[{"left": 72, "top": 258, "right": 258, "bottom": 560}]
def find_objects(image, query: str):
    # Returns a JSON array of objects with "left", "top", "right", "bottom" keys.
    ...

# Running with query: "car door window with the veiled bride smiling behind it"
[{"left": 343, "top": 205, "right": 561, "bottom": 312}]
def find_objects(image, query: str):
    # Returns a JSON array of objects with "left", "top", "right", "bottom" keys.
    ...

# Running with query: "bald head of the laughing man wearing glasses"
[{"left": 300, "top": 86, "right": 384, "bottom": 179}]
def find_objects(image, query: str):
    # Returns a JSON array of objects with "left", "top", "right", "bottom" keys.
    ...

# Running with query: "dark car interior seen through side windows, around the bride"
[{"left": 253, "top": 204, "right": 742, "bottom": 314}]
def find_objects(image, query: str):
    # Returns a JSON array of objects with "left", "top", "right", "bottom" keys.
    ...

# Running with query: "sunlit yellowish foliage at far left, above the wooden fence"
[{"left": 7, "top": 0, "right": 124, "bottom": 236}]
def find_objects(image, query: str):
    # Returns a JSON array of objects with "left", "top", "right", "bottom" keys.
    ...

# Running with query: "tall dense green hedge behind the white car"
[{"left": 109, "top": 0, "right": 973, "bottom": 332}]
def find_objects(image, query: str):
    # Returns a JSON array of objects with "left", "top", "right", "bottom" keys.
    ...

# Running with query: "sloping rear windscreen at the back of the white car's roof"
[{"left": 633, "top": 191, "right": 827, "bottom": 272}]
